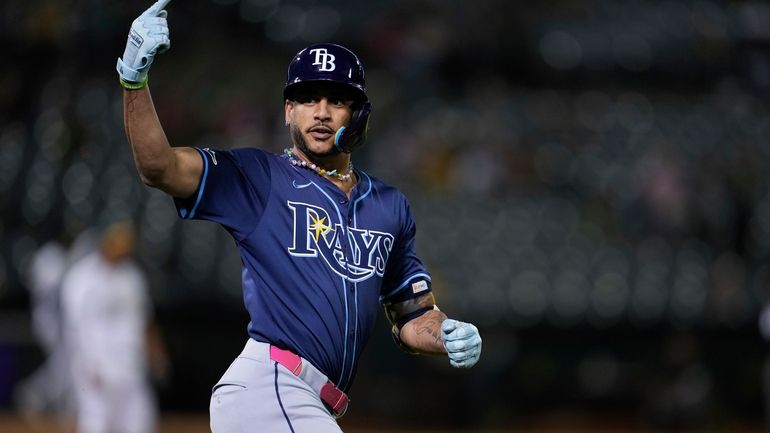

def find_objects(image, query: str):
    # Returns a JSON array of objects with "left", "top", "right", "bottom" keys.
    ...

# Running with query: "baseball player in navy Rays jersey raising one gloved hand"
[{"left": 117, "top": 0, "right": 481, "bottom": 433}]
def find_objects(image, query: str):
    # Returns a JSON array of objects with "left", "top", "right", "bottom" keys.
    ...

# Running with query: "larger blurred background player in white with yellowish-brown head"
[{"left": 62, "top": 222, "right": 167, "bottom": 433}]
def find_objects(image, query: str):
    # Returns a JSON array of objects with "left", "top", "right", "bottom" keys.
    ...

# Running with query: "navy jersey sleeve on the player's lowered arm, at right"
[{"left": 380, "top": 196, "right": 432, "bottom": 303}]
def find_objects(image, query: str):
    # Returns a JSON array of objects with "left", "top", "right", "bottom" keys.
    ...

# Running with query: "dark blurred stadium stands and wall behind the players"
[{"left": 0, "top": 0, "right": 770, "bottom": 427}]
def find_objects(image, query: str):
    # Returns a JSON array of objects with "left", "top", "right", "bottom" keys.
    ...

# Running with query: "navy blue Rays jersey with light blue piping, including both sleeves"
[{"left": 175, "top": 148, "right": 431, "bottom": 390}]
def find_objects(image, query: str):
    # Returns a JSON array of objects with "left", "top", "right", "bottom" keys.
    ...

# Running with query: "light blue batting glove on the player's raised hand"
[{"left": 117, "top": 0, "right": 171, "bottom": 89}]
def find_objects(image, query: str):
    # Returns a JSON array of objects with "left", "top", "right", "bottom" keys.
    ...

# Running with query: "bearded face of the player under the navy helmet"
[{"left": 284, "top": 85, "right": 353, "bottom": 157}]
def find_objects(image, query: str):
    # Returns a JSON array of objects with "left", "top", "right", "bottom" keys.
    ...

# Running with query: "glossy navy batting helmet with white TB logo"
[{"left": 283, "top": 44, "right": 372, "bottom": 153}]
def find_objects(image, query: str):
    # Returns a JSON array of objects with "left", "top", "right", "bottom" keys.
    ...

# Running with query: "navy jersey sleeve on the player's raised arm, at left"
[{"left": 174, "top": 148, "right": 270, "bottom": 240}]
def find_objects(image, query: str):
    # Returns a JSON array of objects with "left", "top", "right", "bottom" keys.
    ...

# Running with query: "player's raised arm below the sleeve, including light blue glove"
[{"left": 117, "top": 0, "right": 203, "bottom": 198}]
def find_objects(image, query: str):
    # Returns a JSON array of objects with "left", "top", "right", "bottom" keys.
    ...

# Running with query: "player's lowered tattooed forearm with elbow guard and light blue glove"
[{"left": 384, "top": 293, "right": 481, "bottom": 368}]
